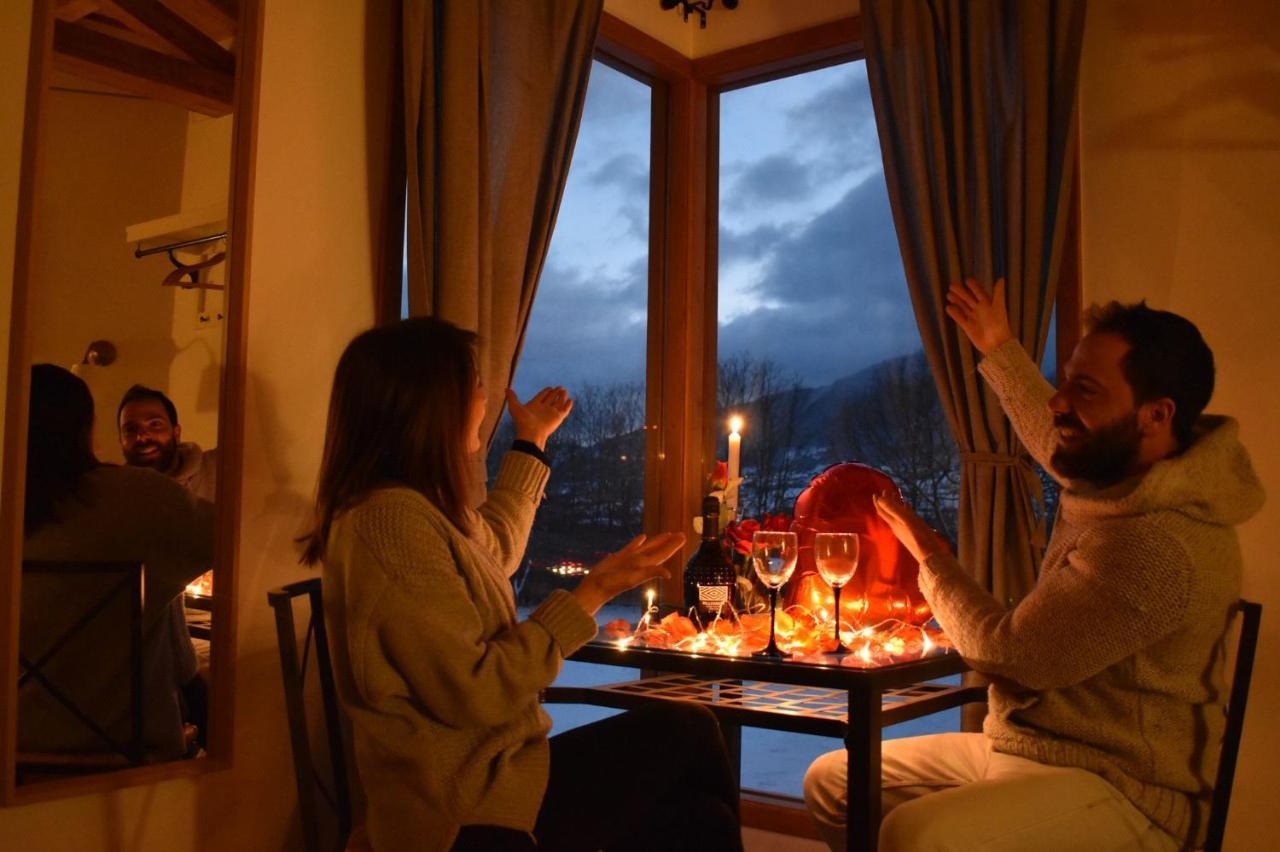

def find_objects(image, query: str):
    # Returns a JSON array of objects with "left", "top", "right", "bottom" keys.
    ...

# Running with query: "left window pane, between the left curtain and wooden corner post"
[{"left": 489, "top": 61, "right": 652, "bottom": 622}]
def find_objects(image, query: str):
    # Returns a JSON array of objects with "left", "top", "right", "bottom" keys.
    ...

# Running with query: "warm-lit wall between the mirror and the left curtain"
[{"left": 0, "top": 0, "right": 390, "bottom": 852}]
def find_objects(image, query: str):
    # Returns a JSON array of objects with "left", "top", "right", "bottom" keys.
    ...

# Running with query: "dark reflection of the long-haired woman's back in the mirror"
[{"left": 18, "top": 365, "right": 214, "bottom": 760}]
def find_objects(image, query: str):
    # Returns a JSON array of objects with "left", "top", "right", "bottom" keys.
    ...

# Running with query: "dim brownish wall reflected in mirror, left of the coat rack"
[{"left": 29, "top": 87, "right": 193, "bottom": 463}]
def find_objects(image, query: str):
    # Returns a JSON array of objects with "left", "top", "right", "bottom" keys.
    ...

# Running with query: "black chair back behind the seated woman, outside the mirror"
[{"left": 266, "top": 577, "right": 352, "bottom": 852}]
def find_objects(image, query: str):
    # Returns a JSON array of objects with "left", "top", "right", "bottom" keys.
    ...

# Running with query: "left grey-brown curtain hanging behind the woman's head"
[{"left": 403, "top": 0, "right": 603, "bottom": 485}]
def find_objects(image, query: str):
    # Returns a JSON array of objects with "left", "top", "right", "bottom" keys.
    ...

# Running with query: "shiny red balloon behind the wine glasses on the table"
[{"left": 786, "top": 462, "right": 933, "bottom": 626}]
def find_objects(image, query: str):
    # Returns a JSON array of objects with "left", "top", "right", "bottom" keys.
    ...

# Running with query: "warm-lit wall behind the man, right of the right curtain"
[{"left": 1080, "top": 0, "right": 1280, "bottom": 849}]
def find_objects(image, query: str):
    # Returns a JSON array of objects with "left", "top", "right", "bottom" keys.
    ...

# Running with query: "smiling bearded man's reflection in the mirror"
[{"left": 116, "top": 385, "right": 218, "bottom": 500}]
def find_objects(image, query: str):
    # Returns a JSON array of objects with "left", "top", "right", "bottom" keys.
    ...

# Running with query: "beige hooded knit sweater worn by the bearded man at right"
[{"left": 920, "top": 342, "right": 1263, "bottom": 846}]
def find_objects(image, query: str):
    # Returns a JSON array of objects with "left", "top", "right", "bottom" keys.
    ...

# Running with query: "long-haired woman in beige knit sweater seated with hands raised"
[{"left": 302, "top": 319, "right": 741, "bottom": 852}]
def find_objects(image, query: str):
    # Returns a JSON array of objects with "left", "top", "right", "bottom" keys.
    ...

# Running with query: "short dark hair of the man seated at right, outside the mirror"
[{"left": 1084, "top": 301, "right": 1213, "bottom": 448}]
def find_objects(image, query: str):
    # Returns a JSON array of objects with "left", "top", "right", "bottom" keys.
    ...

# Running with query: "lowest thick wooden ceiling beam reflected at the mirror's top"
[{"left": 54, "top": 20, "right": 236, "bottom": 116}]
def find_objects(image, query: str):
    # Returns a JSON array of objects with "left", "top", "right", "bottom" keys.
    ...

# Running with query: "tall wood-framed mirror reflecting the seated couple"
[{"left": 0, "top": 0, "right": 260, "bottom": 801}]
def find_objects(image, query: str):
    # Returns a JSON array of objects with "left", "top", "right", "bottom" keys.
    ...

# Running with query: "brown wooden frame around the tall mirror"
[{"left": 0, "top": 0, "right": 264, "bottom": 806}]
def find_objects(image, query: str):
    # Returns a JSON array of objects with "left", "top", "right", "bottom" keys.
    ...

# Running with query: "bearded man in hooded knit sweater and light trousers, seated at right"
[{"left": 805, "top": 281, "right": 1263, "bottom": 851}]
